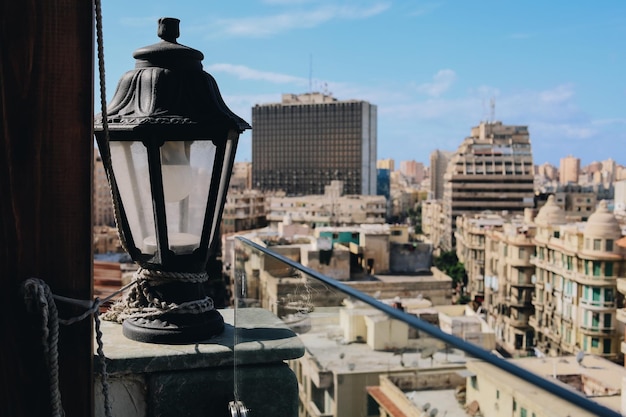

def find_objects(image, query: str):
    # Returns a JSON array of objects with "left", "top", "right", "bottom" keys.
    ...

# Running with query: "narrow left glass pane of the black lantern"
[{"left": 110, "top": 141, "right": 156, "bottom": 253}]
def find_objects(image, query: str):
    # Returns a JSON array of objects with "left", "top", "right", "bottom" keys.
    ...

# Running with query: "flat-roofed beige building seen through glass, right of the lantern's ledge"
[{"left": 290, "top": 298, "right": 493, "bottom": 417}]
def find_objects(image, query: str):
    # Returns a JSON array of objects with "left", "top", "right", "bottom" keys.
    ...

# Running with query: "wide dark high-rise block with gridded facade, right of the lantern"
[{"left": 252, "top": 93, "right": 377, "bottom": 195}]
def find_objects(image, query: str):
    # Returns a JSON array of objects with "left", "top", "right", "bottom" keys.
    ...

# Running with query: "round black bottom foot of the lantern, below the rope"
[{"left": 122, "top": 310, "right": 224, "bottom": 345}]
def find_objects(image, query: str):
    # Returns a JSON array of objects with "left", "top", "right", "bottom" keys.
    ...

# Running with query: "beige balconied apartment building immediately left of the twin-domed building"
[{"left": 455, "top": 209, "right": 535, "bottom": 357}]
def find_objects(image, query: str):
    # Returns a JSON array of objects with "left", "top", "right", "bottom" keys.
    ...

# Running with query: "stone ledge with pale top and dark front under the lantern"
[{"left": 94, "top": 308, "right": 304, "bottom": 417}]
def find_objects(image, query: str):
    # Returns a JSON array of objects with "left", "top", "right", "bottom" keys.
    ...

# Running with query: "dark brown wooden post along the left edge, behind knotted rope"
[{"left": 0, "top": 0, "right": 94, "bottom": 417}]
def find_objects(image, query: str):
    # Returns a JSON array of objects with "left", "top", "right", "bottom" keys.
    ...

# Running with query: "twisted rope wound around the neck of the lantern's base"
[{"left": 102, "top": 268, "right": 215, "bottom": 323}]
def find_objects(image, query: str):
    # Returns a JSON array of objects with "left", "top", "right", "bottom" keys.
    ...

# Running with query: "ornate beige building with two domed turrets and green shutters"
[{"left": 530, "top": 198, "right": 626, "bottom": 360}]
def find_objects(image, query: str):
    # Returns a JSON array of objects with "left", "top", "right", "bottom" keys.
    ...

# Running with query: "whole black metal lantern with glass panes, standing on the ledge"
[{"left": 95, "top": 18, "right": 250, "bottom": 343}]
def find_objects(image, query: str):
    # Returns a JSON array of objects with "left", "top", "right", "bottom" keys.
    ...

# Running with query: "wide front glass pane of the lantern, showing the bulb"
[{"left": 161, "top": 141, "right": 217, "bottom": 254}]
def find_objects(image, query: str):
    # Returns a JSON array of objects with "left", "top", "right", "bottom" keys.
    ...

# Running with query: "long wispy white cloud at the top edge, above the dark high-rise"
[{"left": 210, "top": 2, "right": 390, "bottom": 38}]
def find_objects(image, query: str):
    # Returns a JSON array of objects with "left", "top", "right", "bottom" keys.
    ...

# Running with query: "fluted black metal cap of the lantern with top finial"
[{"left": 94, "top": 17, "right": 251, "bottom": 135}]
